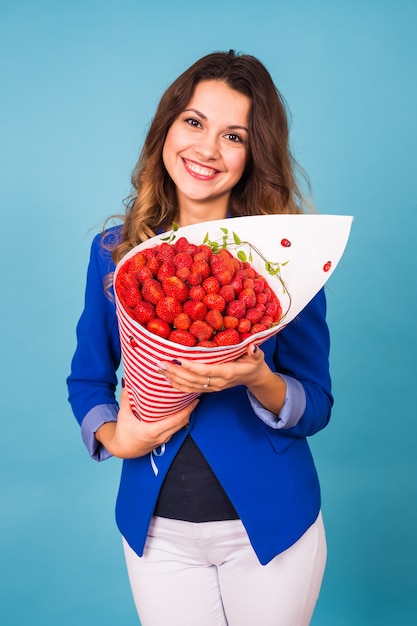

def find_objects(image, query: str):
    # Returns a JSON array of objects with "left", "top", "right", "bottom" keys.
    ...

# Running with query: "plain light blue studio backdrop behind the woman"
[{"left": 0, "top": 0, "right": 417, "bottom": 626}]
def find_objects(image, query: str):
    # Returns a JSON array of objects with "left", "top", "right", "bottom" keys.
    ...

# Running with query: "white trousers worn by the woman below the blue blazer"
[{"left": 123, "top": 514, "right": 327, "bottom": 626}]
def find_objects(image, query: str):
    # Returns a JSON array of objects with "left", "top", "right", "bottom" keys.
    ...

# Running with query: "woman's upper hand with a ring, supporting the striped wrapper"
[{"left": 159, "top": 343, "right": 270, "bottom": 393}]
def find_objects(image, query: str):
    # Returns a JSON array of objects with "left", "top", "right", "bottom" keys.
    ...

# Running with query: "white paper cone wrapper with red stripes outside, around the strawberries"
[{"left": 114, "top": 215, "right": 353, "bottom": 421}]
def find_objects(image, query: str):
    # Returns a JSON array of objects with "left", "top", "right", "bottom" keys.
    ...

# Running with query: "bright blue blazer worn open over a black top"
[{"left": 68, "top": 228, "right": 333, "bottom": 564}]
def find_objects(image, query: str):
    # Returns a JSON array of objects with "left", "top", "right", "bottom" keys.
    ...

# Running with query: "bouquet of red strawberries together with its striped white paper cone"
[{"left": 114, "top": 215, "right": 352, "bottom": 421}]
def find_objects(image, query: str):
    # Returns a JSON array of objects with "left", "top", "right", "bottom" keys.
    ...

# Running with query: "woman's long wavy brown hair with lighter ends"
[{"left": 105, "top": 50, "right": 309, "bottom": 263}]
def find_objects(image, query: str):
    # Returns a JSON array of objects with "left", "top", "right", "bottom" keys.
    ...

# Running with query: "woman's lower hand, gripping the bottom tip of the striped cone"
[{"left": 96, "top": 389, "right": 198, "bottom": 459}]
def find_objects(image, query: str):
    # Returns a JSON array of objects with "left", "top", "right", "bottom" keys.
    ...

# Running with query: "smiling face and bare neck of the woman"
[{"left": 162, "top": 80, "right": 251, "bottom": 226}]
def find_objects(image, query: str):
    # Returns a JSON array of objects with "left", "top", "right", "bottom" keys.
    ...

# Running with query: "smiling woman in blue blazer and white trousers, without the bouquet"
[{"left": 68, "top": 51, "right": 332, "bottom": 626}]
